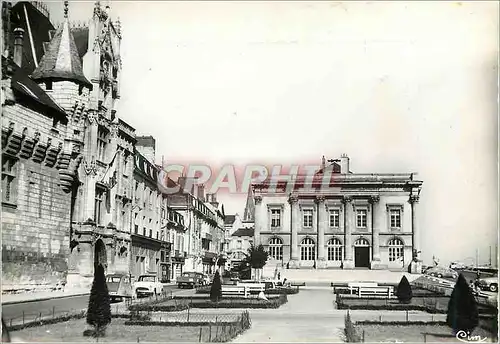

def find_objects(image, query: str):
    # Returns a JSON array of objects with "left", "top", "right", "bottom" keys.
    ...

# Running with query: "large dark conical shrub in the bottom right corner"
[{"left": 446, "top": 274, "right": 479, "bottom": 334}]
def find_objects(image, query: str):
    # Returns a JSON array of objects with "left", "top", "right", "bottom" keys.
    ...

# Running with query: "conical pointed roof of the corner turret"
[{"left": 31, "top": 12, "right": 92, "bottom": 89}]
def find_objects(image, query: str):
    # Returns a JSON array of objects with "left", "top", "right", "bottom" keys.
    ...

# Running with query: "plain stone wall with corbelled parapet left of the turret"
[{"left": 1, "top": 104, "right": 71, "bottom": 290}]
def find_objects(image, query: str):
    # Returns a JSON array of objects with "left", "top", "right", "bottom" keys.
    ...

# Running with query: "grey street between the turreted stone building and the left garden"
[{"left": 2, "top": 285, "right": 195, "bottom": 325}]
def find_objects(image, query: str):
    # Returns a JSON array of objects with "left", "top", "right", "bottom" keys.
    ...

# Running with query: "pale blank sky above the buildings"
[{"left": 45, "top": 1, "right": 499, "bottom": 262}]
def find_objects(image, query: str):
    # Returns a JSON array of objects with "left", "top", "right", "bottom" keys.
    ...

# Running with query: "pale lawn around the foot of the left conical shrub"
[{"left": 11, "top": 319, "right": 215, "bottom": 343}]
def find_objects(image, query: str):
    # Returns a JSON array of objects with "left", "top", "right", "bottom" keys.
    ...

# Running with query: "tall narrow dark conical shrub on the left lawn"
[{"left": 87, "top": 264, "right": 111, "bottom": 337}]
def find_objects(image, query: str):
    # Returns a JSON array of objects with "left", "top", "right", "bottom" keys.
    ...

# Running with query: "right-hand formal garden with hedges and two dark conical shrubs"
[{"left": 342, "top": 275, "right": 498, "bottom": 343}]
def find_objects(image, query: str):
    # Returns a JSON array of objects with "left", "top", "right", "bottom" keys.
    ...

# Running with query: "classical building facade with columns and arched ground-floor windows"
[{"left": 251, "top": 155, "right": 422, "bottom": 270}]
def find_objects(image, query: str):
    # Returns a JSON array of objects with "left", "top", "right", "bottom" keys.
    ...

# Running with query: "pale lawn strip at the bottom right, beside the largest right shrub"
[{"left": 356, "top": 325, "right": 495, "bottom": 343}]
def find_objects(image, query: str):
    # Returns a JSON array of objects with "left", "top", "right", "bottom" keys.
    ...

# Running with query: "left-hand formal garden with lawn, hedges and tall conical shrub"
[{"left": 4, "top": 247, "right": 298, "bottom": 343}]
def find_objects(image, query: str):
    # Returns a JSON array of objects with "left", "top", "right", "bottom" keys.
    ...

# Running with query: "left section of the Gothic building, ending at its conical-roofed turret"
[{"left": 2, "top": 2, "right": 93, "bottom": 290}]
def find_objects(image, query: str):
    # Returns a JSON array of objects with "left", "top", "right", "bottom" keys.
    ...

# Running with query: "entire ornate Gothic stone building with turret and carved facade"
[{"left": 2, "top": 2, "right": 135, "bottom": 286}]
